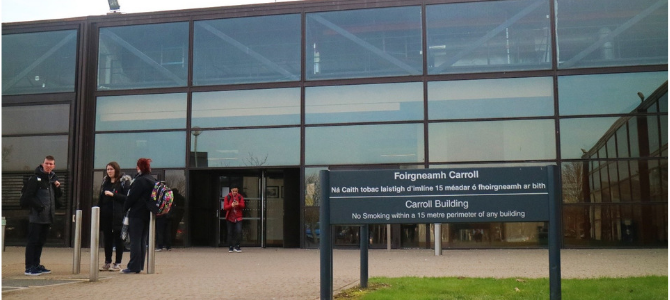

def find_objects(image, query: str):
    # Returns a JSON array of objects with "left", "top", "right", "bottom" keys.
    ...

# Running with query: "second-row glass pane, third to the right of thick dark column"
[{"left": 305, "top": 82, "right": 423, "bottom": 124}]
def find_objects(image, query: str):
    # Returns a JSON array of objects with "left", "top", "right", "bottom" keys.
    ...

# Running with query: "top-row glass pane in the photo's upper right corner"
[{"left": 556, "top": 0, "right": 668, "bottom": 68}]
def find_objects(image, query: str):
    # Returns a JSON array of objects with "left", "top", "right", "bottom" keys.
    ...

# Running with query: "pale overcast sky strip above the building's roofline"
[{"left": 2, "top": 0, "right": 295, "bottom": 23}]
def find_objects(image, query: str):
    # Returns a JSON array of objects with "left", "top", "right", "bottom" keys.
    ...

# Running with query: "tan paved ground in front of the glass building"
[{"left": 2, "top": 247, "right": 668, "bottom": 300}]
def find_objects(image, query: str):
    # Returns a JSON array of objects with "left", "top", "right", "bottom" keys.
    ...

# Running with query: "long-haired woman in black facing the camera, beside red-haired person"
[{"left": 98, "top": 161, "right": 131, "bottom": 271}]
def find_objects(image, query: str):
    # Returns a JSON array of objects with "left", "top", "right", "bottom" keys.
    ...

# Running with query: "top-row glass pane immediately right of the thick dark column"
[{"left": 98, "top": 22, "right": 188, "bottom": 90}]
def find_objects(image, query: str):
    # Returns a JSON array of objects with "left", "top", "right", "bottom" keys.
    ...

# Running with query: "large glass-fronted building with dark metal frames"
[{"left": 2, "top": 0, "right": 668, "bottom": 248}]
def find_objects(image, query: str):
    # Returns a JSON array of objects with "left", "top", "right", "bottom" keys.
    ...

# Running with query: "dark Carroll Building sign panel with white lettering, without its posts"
[{"left": 329, "top": 167, "right": 549, "bottom": 224}]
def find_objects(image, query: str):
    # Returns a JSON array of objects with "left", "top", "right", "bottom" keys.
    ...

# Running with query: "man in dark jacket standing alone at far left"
[{"left": 21, "top": 155, "right": 63, "bottom": 276}]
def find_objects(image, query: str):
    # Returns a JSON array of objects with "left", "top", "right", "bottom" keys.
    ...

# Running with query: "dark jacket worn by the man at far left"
[{"left": 25, "top": 165, "right": 63, "bottom": 224}]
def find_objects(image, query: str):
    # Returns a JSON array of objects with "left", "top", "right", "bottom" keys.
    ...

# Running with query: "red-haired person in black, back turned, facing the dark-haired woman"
[{"left": 121, "top": 158, "right": 156, "bottom": 274}]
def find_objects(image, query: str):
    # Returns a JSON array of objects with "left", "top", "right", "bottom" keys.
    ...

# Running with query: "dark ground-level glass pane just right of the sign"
[{"left": 563, "top": 204, "right": 668, "bottom": 248}]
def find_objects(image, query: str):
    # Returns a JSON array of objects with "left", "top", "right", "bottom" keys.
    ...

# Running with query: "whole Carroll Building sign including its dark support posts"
[{"left": 319, "top": 166, "right": 561, "bottom": 300}]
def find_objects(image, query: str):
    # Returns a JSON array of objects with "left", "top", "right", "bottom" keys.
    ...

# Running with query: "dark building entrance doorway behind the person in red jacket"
[{"left": 189, "top": 168, "right": 300, "bottom": 247}]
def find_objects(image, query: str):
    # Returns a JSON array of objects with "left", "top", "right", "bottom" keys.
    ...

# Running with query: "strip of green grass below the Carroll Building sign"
[{"left": 334, "top": 276, "right": 668, "bottom": 300}]
